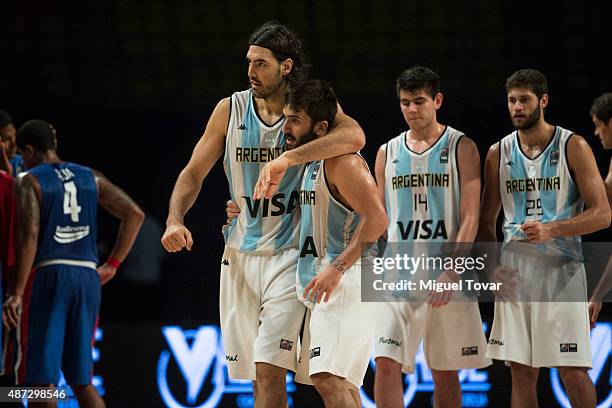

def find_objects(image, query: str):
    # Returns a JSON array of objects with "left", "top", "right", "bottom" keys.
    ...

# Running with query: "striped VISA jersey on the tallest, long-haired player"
[{"left": 223, "top": 90, "right": 304, "bottom": 253}]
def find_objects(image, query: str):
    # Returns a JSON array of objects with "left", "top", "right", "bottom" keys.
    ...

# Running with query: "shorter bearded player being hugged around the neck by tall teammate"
[{"left": 274, "top": 80, "right": 387, "bottom": 408}]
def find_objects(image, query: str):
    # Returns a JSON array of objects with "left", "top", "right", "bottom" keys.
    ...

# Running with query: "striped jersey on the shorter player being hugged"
[{"left": 297, "top": 160, "right": 360, "bottom": 297}]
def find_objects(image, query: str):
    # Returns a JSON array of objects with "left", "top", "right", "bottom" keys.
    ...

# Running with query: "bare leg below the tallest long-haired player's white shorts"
[{"left": 255, "top": 363, "right": 287, "bottom": 408}]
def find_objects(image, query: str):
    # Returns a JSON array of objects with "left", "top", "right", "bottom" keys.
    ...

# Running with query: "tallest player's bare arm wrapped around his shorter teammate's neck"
[{"left": 254, "top": 104, "right": 365, "bottom": 198}]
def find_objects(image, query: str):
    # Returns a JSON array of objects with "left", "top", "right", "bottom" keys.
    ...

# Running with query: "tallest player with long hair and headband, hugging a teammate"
[{"left": 162, "top": 22, "right": 365, "bottom": 408}]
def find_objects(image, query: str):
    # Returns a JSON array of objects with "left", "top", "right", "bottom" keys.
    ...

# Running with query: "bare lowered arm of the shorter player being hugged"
[{"left": 304, "top": 155, "right": 388, "bottom": 303}]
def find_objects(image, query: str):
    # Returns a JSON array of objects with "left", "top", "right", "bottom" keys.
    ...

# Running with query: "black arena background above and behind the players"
[{"left": 0, "top": 0, "right": 612, "bottom": 404}]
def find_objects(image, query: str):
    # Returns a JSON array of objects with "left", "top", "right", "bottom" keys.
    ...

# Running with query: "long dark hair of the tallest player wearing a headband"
[{"left": 249, "top": 20, "right": 309, "bottom": 86}]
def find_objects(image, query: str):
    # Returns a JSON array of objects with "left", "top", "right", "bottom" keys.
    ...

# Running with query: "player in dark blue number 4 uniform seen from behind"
[{"left": 2, "top": 120, "right": 144, "bottom": 407}]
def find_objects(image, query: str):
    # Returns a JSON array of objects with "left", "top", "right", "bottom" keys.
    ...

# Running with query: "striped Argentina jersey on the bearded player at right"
[{"left": 499, "top": 126, "right": 584, "bottom": 242}]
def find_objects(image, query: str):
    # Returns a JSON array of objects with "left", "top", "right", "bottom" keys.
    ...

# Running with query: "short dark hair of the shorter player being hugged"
[{"left": 285, "top": 79, "right": 338, "bottom": 127}]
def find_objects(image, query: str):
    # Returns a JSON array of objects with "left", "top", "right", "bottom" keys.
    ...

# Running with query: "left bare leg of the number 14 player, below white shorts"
[{"left": 374, "top": 357, "right": 404, "bottom": 408}]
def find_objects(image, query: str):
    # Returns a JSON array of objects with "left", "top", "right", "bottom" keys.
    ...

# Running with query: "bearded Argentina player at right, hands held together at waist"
[{"left": 479, "top": 69, "right": 610, "bottom": 407}]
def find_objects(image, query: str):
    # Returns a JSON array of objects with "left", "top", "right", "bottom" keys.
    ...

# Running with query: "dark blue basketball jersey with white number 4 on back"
[{"left": 29, "top": 162, "right": 98, "bottom": 263}]
